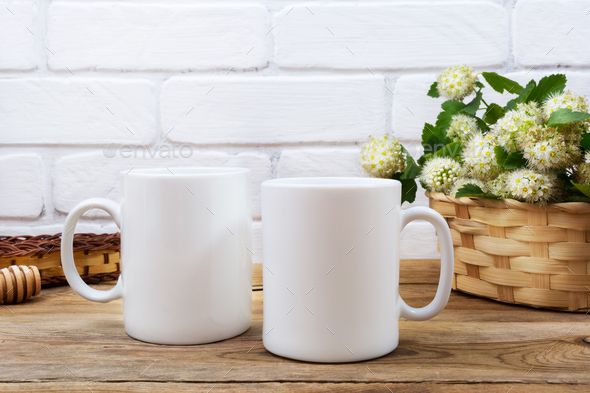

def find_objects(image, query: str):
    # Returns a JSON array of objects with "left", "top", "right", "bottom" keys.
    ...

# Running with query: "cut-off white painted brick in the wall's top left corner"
[{"left": 0, "top": 2, "right": 40, "bottom": 70}]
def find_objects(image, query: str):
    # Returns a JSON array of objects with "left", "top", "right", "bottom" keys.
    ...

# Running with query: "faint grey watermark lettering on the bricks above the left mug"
[{"left": 102, "top": 143, "right": 193, "bottom": 158}]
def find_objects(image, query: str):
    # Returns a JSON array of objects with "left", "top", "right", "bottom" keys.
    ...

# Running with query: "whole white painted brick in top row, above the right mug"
[{"left": 273, "top": 1, "right": 509, "bottom": 69}]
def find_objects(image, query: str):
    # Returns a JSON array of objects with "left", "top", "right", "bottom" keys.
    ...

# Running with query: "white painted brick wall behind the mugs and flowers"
[{"left": 0, "top": 0, "right": 590, "bottom": 262}]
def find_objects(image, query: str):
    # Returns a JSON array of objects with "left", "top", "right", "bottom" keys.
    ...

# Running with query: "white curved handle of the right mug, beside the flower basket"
[{"left": 399, "top": 206, "right": 455, "bottom": 321}]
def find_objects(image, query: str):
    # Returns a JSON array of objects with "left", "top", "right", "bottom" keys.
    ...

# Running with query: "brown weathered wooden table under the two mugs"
[{"left": 0, "top": 260, "right": 590, "bottom": 393}]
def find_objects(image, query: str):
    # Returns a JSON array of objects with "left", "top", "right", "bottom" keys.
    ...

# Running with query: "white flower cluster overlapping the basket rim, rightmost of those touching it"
[{"left": 506, "top": 169, "right": 554, "bottom": 202}]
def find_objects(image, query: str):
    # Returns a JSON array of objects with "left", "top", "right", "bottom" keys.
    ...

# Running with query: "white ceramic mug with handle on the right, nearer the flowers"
[{"left": 262, "top": 178, "right": 454, "bottom": 362}]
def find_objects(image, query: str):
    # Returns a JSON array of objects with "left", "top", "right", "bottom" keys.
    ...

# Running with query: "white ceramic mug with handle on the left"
[{"left": 61, "top": 168, "right": 252, "bottom": 345}]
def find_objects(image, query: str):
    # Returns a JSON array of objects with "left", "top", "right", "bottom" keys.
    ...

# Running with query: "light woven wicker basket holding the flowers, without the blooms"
[{"left": 426, "top": 192, "right": 590, "bottom": 312}]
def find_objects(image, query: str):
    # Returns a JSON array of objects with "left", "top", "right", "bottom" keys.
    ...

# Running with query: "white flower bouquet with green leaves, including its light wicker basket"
[{"left": 360, "top": 66, "right": 590, "bottom": 311}]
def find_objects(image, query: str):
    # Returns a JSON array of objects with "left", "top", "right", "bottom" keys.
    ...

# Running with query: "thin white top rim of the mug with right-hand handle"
[{"left": 262, "top": 176, "right": 401, "bottom": 189}]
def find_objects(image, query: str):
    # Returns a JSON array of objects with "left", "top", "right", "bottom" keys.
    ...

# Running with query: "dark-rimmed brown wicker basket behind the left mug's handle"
[{"left": 0, "top": 233, "right": 121, "bottom": 288}]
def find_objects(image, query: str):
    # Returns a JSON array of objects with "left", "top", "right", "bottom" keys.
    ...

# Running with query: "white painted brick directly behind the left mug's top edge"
[{"left": 52, "top": 149, "right": 271, "bottom": 217}]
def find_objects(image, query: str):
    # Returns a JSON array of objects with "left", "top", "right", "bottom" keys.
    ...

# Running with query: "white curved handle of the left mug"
[{"left": 61, "top": 198, "right": 123, "bottom": 303}]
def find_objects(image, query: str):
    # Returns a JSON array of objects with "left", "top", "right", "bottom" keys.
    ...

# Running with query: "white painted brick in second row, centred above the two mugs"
[{"left": 161, "top": 75, "right": 391, "bottom": 144}]
